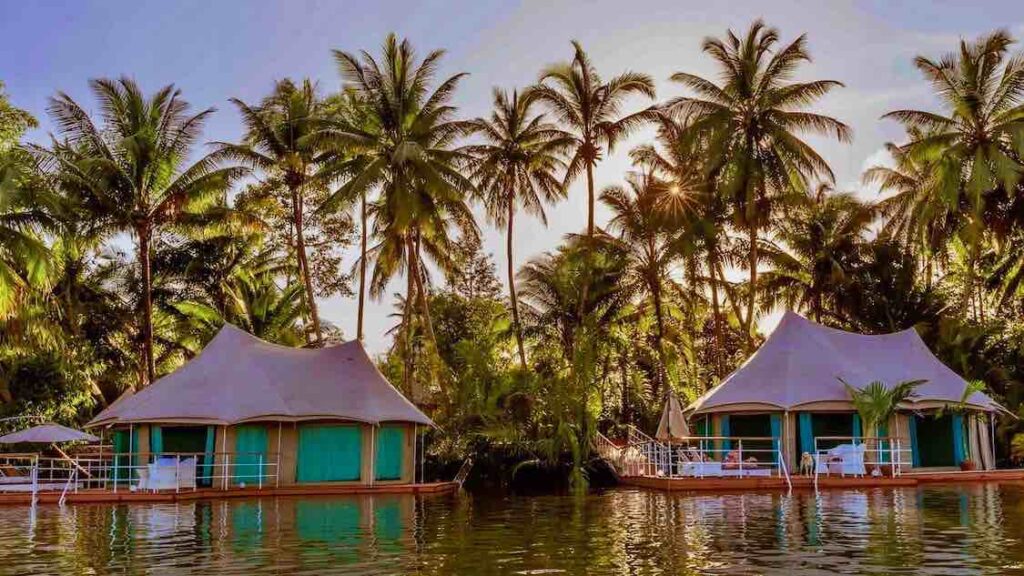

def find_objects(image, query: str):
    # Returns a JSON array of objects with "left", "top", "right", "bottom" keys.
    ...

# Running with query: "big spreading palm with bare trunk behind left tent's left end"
[{"left": 37, "top": 77, "right": 247, "bottom": 385}]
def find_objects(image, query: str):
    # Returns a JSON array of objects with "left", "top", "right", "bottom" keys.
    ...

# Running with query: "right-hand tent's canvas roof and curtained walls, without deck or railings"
[{"left": 686, "top": 312, "right": 1005, "bottom": 469}]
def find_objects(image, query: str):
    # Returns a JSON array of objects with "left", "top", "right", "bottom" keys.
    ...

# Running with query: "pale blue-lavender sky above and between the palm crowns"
[{"left": 0, "top": 0, "right": 1024, "bottom": 353}]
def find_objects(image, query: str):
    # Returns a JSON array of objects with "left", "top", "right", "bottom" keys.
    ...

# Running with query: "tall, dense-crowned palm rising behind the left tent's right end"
[{"left": 325, "top": 34, "right": 478, "bottom": 389}]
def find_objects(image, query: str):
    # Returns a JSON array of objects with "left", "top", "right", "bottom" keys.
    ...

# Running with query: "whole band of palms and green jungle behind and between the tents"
[{"left": 0, "top": 20, "right": 1024, "bottom": 489}]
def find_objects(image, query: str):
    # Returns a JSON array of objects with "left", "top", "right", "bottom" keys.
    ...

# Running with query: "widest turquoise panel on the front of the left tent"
[{"left": 295, "top": 424, "right": 362, "bottom": 482}]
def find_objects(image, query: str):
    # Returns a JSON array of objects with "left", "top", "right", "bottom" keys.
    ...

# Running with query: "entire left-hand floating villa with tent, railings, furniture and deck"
[{"left": 0, "top": 325, "right": 454, "bottom": 500}]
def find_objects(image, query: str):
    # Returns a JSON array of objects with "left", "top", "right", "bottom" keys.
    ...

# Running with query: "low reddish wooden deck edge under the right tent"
[{"left": 620, "top": 469, "right": 1024, "bottom": 492}]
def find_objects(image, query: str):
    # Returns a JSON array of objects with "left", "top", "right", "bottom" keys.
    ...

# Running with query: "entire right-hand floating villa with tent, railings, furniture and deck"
[{"left": 598, "top": 312, "right": 1021, "bottom": 489}]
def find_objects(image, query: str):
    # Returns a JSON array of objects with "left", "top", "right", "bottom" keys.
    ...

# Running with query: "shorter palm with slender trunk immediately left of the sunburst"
[{"left": 601, "top": 172, "right": 680, "bottom": 398}]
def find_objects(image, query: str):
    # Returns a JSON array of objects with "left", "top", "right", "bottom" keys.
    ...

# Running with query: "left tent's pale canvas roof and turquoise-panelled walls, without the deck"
[{"left": 87, "top": 325, "right": 433, "bottom": 486}]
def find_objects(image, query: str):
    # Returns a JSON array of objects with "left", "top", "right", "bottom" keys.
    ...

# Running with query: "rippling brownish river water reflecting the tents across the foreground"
[{"left": 0, "top": 484, "right": 1024, "bottom": 576}]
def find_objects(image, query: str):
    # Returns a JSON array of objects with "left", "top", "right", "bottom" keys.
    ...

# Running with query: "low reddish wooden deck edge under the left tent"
[{"left": 0, "top": 482, "right": 459, "bottom": 504}]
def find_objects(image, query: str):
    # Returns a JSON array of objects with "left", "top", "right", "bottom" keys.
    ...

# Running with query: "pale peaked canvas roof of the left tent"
[{"left": 86, "top": 325, "right": 433, "bottom": 427}]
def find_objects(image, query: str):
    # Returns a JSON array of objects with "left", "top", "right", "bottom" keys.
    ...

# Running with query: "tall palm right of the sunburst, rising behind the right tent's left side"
[{"left": 667, "top": 20, "right": 851, "bottom": 346}]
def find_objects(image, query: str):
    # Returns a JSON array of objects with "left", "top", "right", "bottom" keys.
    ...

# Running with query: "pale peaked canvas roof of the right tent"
[{"left": 687, "top": 312, "right": 1004, "bottom": 413}]
